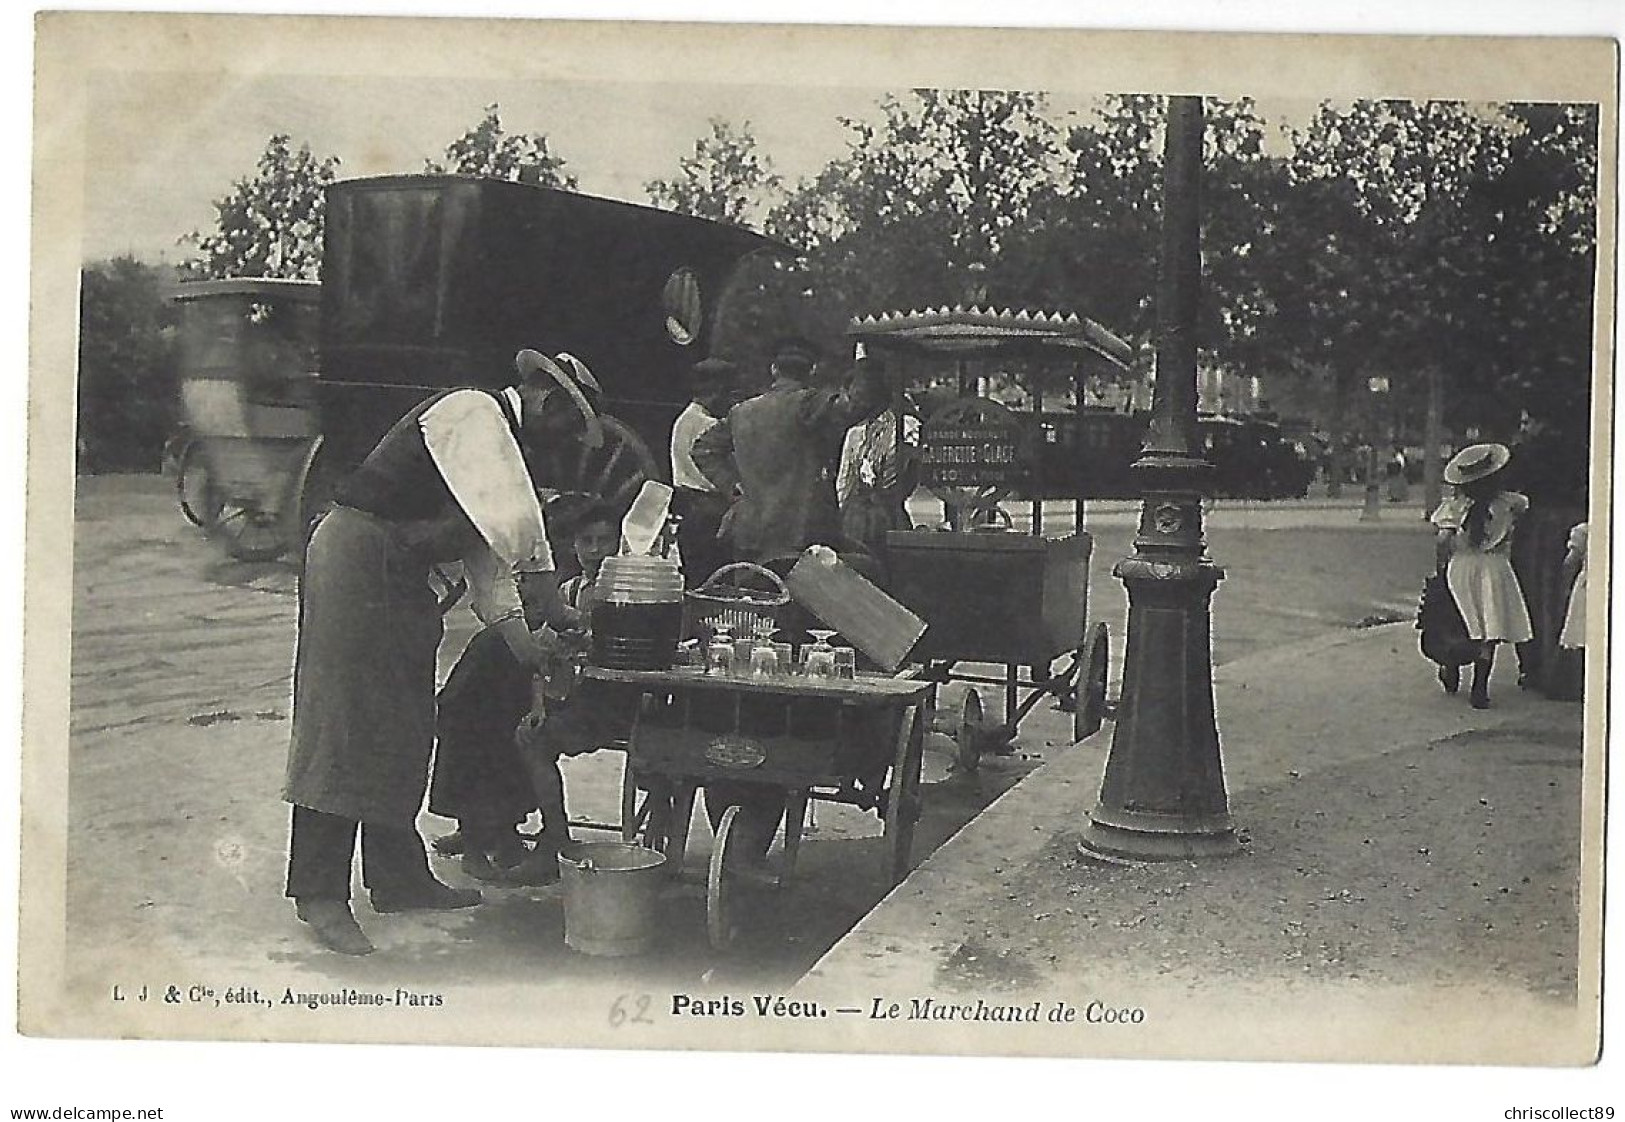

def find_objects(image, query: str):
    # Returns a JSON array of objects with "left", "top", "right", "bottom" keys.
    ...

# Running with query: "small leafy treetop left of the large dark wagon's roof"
[{"left": 180, "top": 133, "right": 340, "bottom": 280}]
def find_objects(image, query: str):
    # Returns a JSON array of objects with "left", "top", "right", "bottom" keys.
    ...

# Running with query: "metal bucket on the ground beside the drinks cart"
[{"left": 559, "top": 842, "right": 666, "bottom": 958}]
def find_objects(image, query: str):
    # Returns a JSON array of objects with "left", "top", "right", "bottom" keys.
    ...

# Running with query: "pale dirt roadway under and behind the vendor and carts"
[{"left": 67, "top": 476, "right": 1428, "bottom": 994}]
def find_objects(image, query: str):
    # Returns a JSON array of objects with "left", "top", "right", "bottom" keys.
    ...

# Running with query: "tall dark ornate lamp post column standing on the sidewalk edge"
[{"left": 1079, "top": 98, "right": 1240, "bottom": 860}]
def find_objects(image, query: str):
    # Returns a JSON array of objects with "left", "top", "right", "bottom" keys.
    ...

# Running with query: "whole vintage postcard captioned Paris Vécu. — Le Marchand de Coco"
[{"left": 18, "top": 2, "right": 1619, "bottom": 1086}]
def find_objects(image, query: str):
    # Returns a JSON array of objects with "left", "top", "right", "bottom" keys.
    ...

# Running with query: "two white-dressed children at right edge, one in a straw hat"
[{"left": 1432, "top": 444, "right": 1588, "bottom": 709}]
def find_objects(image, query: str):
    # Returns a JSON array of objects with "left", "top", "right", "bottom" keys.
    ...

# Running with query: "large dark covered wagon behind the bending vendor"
[{"left": 171, "top": 176, "right": 783, "bottom": 556}]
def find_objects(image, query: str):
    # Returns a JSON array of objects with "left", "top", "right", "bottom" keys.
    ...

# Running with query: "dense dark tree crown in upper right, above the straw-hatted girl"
[{"left": 1276, "top": 101, "right": 1596, "bottom": 455}]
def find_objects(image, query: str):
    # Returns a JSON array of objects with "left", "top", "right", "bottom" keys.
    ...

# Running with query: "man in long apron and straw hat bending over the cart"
[{"left": 283, "top": 350, "right": 601, "bottom": 955}]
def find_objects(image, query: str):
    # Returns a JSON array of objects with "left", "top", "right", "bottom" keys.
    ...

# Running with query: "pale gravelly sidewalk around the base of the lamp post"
[{"left": 798, "top": 624, "right": 1601, "bottom": 1063}]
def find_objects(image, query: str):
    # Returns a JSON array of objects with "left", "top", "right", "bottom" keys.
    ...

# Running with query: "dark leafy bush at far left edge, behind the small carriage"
[{"left": 78, "top": 257, "right": 176, "bottom": 472}]
